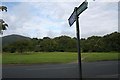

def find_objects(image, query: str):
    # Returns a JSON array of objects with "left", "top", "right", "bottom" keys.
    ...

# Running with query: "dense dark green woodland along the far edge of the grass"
[{"left": 3, "top": 32, "right": 120, "bottom": 53}]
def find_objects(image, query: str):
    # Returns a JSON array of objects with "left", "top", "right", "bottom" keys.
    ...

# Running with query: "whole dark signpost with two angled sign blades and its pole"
[{"left": 68, "top": 0, "right": 88, "bottom": 80}]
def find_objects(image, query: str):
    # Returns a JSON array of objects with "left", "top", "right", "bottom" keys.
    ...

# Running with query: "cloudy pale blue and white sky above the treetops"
[{"left": 0, "top": 1, "right": 118, "bottom": 38}]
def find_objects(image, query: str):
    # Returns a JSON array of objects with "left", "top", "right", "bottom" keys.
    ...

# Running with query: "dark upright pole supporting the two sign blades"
[{"left": 75, "top": 7, "right": 82, "bottom": 80}]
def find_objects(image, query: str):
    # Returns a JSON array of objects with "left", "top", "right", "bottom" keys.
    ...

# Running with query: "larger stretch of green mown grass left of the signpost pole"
[{"left": 2, "top": 52, "right": 77, "bottom": 64}]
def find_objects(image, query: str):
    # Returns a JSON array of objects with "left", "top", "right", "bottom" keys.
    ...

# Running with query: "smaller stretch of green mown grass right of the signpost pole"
[{"left": 82, "top": 52, "right": 120, "bottom": 62}]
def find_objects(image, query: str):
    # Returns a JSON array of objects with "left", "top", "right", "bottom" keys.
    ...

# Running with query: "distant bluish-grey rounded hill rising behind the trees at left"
[{"left": 2, "top": 34, "right": 31, "bottom": 46}]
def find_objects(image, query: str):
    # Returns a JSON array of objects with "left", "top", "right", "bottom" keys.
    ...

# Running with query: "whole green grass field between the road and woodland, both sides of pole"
[{"left": 2, "top": 52, "right": 118, "bottom": 64}]
